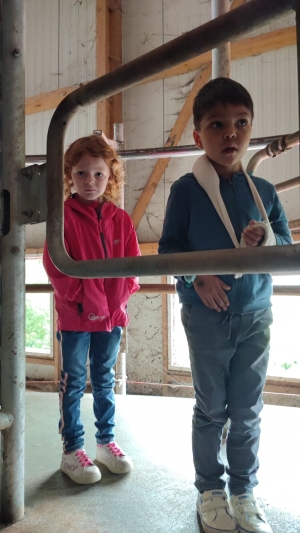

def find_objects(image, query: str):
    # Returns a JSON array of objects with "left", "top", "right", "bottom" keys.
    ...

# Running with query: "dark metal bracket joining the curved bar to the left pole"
[{"left": 18, "top": 164, "right": 47, "bottom": 225}]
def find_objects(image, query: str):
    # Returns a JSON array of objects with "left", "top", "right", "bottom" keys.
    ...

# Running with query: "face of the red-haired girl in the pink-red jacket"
[{"left": 71, "top": 153, "right": 110, "bottom": 204}]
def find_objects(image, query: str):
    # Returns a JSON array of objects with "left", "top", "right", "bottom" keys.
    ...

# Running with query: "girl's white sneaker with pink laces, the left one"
[{"left": 60, "top": 449, "right": 101, "bottom": 485}]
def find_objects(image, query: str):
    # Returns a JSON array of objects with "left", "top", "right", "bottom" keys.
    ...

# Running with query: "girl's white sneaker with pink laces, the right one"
[{"left": 96, "top": 442, "right": 133, "bottom": 474}]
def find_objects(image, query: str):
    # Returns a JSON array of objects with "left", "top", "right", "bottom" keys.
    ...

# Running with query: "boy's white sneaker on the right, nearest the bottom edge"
[{"left": 230, "top": 494, "right": 272, "bottom": 533}]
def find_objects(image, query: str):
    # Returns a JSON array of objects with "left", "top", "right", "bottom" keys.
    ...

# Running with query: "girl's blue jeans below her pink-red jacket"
[{"left": 57, "top": 327, "right": 122, "bottom": 452}]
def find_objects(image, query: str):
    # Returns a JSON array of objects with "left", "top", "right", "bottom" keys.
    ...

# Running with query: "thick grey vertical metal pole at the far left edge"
[{"left": 1, "top": 0, "right": 25, "bottom": 523}]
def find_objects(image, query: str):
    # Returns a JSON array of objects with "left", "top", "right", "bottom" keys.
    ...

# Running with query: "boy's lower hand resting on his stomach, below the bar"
[{"left": 194, "top": 276, "right": 231, "bottom": 313}]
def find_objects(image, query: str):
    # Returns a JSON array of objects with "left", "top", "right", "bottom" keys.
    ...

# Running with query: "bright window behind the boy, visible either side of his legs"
[{"left": 168, "top": 276, "right": 300, "bottom": 378}]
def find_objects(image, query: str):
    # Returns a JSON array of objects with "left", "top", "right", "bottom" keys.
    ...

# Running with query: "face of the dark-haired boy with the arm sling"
[{"left": 193, "top": 103, "right": 252, "bottom": 178}]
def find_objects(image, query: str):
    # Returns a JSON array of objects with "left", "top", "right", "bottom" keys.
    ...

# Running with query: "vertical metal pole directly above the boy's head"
[{"left": 211, "top": 0, "right": 230, "bottom": 79}]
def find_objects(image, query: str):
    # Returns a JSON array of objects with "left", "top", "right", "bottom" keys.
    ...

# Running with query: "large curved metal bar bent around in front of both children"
[{"left": 47, "top": 0, "right": 300, "bottom": 278}]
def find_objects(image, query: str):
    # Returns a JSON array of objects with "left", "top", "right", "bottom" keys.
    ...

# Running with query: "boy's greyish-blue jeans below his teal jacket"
[{"left": 181, "top": 304, "right": 272, "bottom": 495}]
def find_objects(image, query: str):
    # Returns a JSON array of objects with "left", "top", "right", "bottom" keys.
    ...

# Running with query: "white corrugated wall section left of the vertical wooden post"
[{"left": 25, "top": 0, "right": 97, "bottom": 248}]
